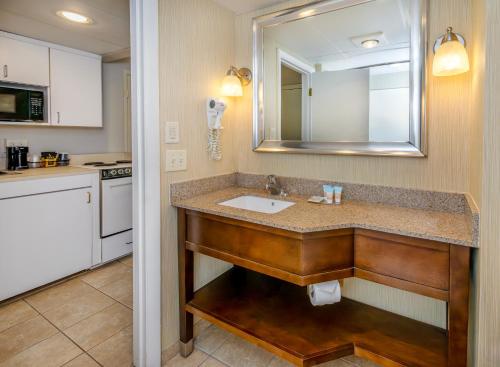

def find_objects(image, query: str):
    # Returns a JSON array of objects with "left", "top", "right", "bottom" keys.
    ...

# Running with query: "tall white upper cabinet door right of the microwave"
[{"left": 50, "top": 48, "right": 102, "bottom": 127}]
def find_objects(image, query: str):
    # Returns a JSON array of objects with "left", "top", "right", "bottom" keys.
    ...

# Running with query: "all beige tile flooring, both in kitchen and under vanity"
[{"left": 0, "top": 257, "right": 376, "bottom": 367}]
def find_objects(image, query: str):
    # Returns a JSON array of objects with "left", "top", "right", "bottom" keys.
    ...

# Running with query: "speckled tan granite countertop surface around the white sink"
[{"left": 172, "top": 186, "right": 477, "bottom": 247}]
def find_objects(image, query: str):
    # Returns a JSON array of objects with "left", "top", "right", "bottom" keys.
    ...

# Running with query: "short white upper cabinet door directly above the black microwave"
[{"left": 0, "top": 35, "right": 50, "bottom": 87}]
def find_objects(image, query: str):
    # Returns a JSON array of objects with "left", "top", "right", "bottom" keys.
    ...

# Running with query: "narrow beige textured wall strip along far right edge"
[{"left": 475, "top": 0, "right": 500, "bottom": 367}]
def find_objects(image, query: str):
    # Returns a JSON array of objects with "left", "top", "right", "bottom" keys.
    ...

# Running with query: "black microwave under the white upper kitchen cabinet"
[{"left": 0, "top": 85, "right": 45, "bottom": 122}]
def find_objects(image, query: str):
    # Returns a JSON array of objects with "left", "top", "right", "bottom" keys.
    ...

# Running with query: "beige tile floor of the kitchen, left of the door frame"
[{"left": 0, "top": 256, "right": 133, "bottom": 367}]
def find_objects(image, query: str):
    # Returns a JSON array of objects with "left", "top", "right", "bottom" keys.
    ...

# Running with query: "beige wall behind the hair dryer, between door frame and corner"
[{"left": 159, "top": 0, "right": 237, "bottom": 349}]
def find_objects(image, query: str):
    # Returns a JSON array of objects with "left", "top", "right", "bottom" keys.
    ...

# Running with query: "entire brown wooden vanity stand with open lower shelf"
[{"left": 178, "top": 209, "right": 470, "bottom": 367}]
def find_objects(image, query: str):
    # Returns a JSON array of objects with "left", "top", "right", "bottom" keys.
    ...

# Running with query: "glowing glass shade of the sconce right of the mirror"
[{"left": 432, "top": 40, "right": 470, "bottom": 76}]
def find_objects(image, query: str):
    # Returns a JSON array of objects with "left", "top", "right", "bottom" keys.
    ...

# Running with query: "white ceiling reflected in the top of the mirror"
[{"left": 264, "top": 0, "right": 410, "bottom": 69}]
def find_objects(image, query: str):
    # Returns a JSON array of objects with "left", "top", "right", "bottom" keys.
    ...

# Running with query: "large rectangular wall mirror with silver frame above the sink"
[{"left": 253, "top": 0, "right": 428, "bottom": 157}]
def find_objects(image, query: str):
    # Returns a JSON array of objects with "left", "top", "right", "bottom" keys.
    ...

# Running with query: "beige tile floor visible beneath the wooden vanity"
[{"left": 164, "top": 320, "right": 378, "bottom": 367}]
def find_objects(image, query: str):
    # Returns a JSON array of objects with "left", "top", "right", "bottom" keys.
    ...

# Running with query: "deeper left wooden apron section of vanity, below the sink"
[{"left": 186, "top": 211, "right": 354, "bottom": 286}]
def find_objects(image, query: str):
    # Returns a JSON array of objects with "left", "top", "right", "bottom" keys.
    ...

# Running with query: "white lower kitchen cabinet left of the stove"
[{"left": 0, "top": 175, "right": 95, "bottom": 300}]
